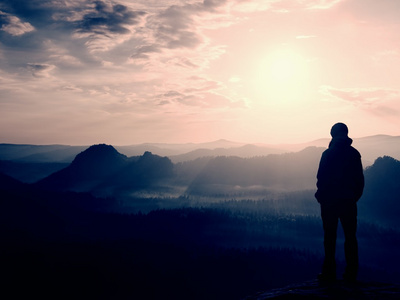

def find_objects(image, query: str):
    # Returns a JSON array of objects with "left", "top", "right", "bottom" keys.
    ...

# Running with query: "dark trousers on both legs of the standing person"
[{"left": 321, "top": 203, "right": 358, "bottom": 278}]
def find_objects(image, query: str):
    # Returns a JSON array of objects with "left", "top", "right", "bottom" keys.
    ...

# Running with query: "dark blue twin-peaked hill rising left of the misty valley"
[{"left": 35, "top": 144, "right": 173, "bottom": 195}]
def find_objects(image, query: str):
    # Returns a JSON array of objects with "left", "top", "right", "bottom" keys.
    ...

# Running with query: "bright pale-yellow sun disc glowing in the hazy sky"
[{"left": 253, "top": 50, "right": 309, "bottom": 101}]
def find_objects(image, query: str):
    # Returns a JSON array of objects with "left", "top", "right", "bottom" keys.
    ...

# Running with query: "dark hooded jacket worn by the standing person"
[{"left": 315, "top": 136, "right": 364, "bottom": 204}]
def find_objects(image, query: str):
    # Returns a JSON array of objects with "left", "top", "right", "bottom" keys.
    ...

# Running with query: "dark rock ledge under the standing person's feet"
[{"left": 245, "top": 280, "right": 400, "bottom": 300}]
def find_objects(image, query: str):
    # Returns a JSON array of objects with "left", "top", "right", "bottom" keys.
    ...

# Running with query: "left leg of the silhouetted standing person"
[{"left": 321, "top": 205, "right": 338, "bottom": 280}]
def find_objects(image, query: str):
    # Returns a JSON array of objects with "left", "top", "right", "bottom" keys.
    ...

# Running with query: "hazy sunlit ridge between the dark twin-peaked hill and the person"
[{"left": 188, "top": 147, "right": 324, "bottom": 195}]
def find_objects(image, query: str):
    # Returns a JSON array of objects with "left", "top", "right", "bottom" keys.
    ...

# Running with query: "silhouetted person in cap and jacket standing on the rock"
[{"left": 315, "top": 123, "right": 364, "bottom": 281}]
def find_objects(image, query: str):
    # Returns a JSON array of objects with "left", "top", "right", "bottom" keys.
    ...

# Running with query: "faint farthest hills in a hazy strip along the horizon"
[{"left": 0, "top": 135, "right": 400, "bottom": 166}]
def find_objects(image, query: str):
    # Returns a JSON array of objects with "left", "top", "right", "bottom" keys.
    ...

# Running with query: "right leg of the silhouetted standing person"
[{"left": 340, "top": 204, "right": 358, "bottom": 281}]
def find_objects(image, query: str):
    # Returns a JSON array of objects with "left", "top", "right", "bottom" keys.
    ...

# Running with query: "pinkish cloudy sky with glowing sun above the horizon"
[{"left": 0, "top": 0, "right": 400, "bottom": 145}]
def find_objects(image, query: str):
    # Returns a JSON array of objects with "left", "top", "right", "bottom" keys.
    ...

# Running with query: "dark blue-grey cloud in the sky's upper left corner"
[{"left": 0, "top": 0, "right": 146, "bottom": 55}]
